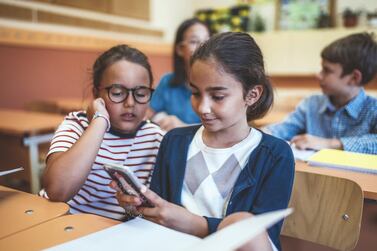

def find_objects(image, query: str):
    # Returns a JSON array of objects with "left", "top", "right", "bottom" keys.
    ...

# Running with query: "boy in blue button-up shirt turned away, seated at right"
[{"left": 265, "top": 33, "right": 377, "bottom": 154}]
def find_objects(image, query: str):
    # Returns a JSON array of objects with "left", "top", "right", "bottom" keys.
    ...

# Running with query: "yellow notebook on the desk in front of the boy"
[{"left": 308, "top": 149, "right": 377, "bottom": 174}]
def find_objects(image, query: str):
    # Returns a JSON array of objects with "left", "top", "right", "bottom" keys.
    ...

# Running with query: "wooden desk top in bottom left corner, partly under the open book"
[{"left": 0, "top": 214, "right": 121, "bottom": 250}]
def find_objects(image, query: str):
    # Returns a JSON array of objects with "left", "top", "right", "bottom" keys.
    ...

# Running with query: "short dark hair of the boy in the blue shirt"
[{"left": 321, "top": 32, "right": 377, "bottom": 85}]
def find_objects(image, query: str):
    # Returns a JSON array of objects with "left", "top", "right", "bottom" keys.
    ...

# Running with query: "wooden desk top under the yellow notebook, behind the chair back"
[{"left": 296, "top": 161, "right": 377, "bottom": 200}]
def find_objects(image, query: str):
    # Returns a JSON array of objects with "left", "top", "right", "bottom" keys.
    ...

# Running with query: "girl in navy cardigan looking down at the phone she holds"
[{"left": 111, "top": 32, "right": 294, "bottom": 250}]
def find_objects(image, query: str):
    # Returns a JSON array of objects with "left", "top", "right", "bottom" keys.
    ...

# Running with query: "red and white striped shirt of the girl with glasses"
[{"left": 48, "top": 112, "right": 164, "bottom": 219}]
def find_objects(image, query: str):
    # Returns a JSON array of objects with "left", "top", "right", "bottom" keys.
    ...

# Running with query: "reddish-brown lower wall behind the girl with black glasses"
[{"left": 0, "top": 45, "right": 171, "bottom": 108}]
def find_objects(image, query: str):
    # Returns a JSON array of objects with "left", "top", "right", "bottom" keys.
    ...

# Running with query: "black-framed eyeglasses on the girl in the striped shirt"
[{"left": 104, "top": 84, "right": 153, "bottom": 104}]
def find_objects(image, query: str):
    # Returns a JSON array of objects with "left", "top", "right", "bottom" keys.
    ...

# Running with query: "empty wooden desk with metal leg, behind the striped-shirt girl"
[{"left": 0, "top": 108, "right": 63, "bottom": 193}]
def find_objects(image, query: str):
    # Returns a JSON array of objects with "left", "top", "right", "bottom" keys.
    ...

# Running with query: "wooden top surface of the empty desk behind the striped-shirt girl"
[{"left": 0, "top": 108, "right": 64, "bottom": 136}]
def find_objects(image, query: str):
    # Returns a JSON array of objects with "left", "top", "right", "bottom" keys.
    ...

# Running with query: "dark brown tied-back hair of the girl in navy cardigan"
[{"left": 190, "top": 32, "right": 274, "bottom": 121}]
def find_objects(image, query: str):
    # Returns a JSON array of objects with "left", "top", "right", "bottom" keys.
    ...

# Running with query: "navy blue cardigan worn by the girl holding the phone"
[{"left": 151, "top": 126, "right": 294, "bottom": 250}]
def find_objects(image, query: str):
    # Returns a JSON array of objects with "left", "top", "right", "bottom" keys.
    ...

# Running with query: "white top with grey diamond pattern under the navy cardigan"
[{"left": 182, "top": 127, "right": 262, "bottom": 218}]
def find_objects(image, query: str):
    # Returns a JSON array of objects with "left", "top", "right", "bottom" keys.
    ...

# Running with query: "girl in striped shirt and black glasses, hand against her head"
[{"left": 42, "top": 45, "right": 163, "bottom": 219}]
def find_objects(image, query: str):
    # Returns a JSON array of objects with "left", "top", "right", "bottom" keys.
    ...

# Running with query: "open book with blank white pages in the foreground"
[{"left": 48, "top": 209, "right": 292, "bottom": 251}]
